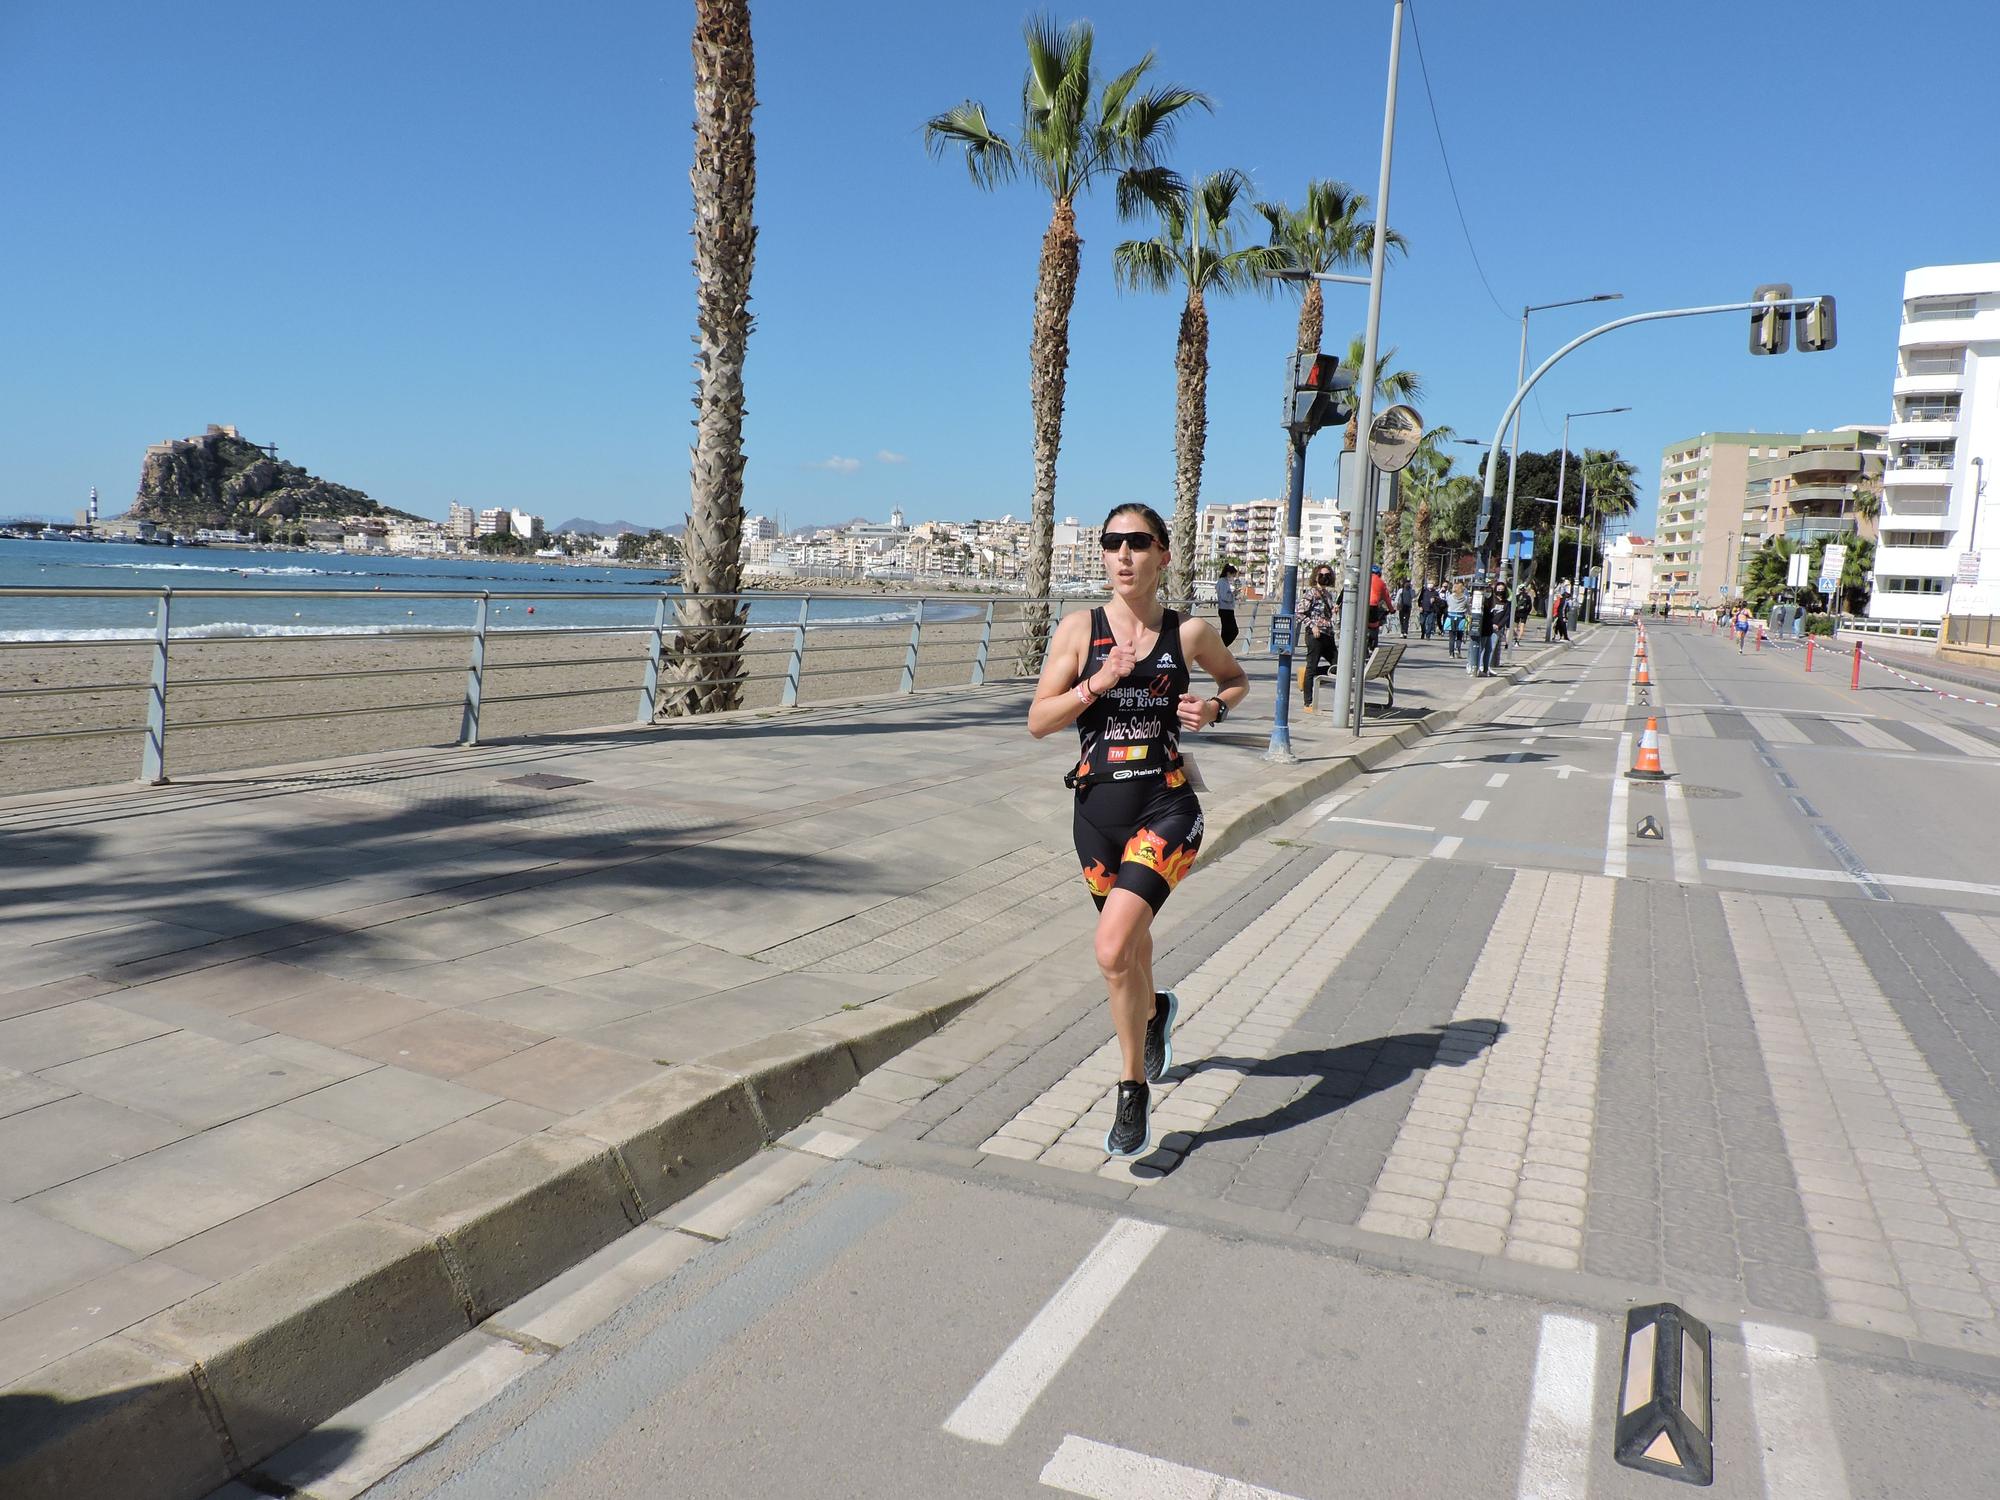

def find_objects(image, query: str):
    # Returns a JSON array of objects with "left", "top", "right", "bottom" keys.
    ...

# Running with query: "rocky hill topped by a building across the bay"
[{"left": 130, "top": 426, "right": 418, "bottom": 530}]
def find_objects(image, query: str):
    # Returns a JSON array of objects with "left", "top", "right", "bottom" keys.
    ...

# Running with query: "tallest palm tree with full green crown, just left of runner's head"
[{"left": 924, "top": 16, "right": 1208, "bottom": 674}]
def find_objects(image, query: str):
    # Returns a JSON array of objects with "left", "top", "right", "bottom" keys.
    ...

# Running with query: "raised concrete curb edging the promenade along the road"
[{"left": 0, "top": 648, "right": 1584, "bottom": 1500}]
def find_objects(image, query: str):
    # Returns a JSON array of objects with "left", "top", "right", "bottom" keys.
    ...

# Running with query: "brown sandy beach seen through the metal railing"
[{"left": 0, "top": 604, "right": 1064, "bottom": 794}]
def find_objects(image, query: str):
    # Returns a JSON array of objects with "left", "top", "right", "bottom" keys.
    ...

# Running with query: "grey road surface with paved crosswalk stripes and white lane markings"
[{"left": 246, "top": 626, "right": 2000, "bottom": 1500}]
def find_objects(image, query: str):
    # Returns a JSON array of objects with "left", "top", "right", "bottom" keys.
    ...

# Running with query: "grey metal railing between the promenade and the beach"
[{"left": 0, "top": 586, "right": 1272, "bottom": 784}]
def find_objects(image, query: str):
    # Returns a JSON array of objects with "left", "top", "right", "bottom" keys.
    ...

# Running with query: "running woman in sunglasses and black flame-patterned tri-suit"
[{"left": 1028, "top": 504, "right": 1250, "bottom": 1156}]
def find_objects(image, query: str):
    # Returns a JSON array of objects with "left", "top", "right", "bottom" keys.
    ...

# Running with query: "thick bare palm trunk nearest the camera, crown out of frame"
[{"left": 676, "top": 0, "right": 756, "bottom": 718}]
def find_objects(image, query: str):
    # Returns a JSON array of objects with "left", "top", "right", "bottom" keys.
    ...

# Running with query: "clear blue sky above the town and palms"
[{"left": 0, "top": 0, "right": 2000, "bottom": 524}]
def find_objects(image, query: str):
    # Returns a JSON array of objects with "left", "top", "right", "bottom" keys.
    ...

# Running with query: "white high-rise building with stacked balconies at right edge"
[{"left": 1868, "top": 260, "right": 2000, "bottom": 636}]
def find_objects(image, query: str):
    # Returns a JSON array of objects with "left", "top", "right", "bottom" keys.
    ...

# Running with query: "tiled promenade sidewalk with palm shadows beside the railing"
[{"left": 0, "top": 628, "right": 1544, "bottom": 1494}]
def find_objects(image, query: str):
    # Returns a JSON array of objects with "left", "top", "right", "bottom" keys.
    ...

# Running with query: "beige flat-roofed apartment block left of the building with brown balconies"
[{"left": 1652, "top": 432, "right": 1806, "bottom": 608}]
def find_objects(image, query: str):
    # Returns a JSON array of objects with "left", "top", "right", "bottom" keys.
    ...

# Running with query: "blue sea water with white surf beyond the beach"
[{"left": 0, "top": 538, "right": 982, "bottom": 640}]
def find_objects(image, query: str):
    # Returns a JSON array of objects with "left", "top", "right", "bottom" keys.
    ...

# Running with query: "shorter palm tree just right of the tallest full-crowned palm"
[{"left": 1112, "top": 168, "right": 1286, "bottom": 610}]
